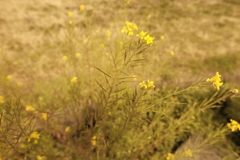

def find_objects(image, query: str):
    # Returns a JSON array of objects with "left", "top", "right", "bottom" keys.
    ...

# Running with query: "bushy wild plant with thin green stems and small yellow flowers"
[{"left": 0, "top": 4, "right": 240, "bottom": 160}]
